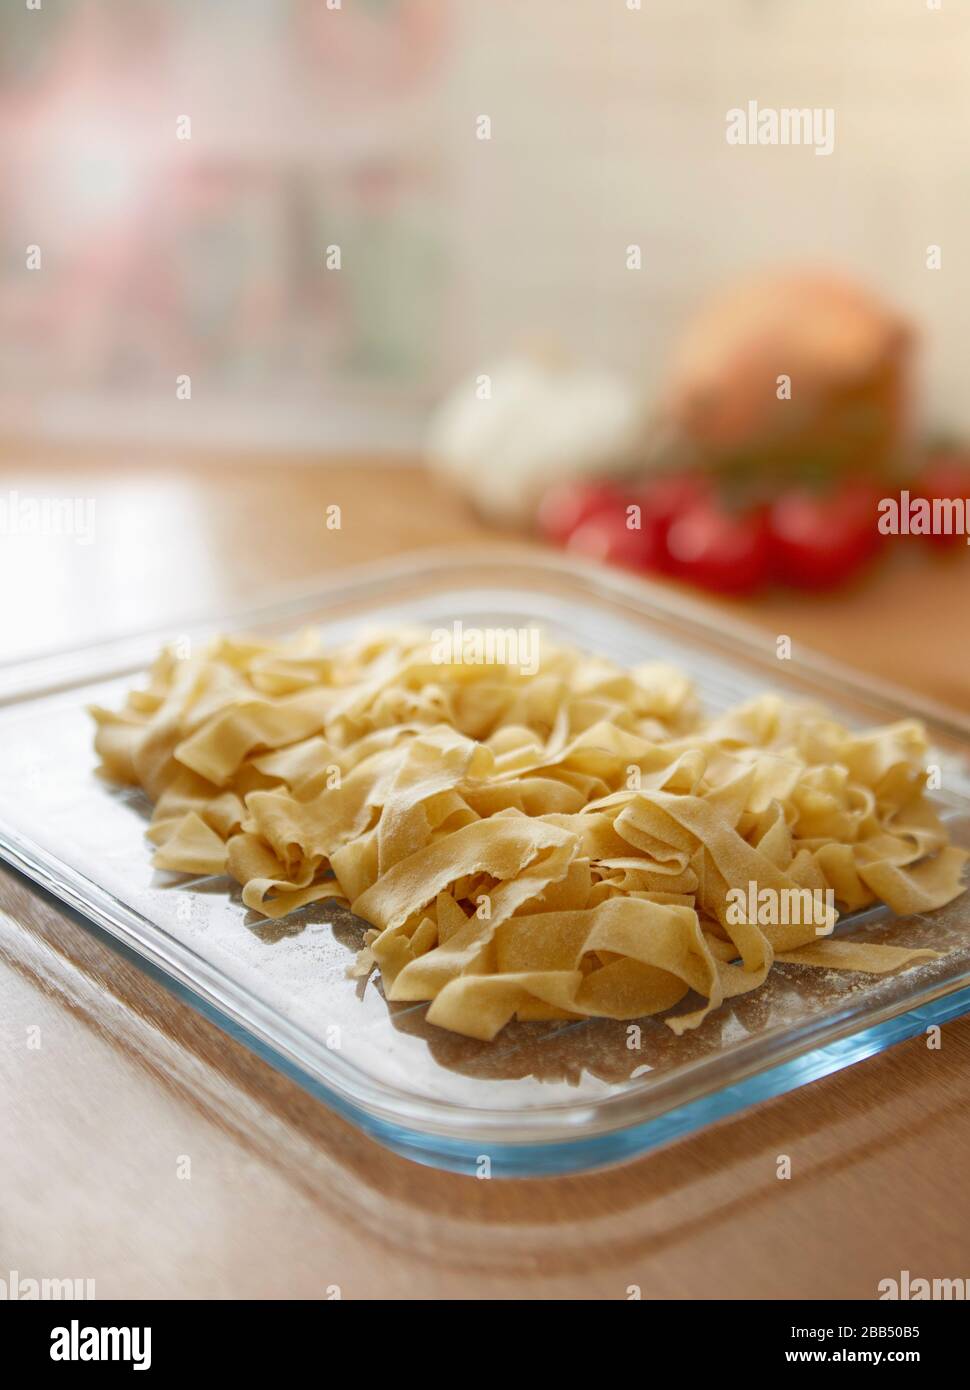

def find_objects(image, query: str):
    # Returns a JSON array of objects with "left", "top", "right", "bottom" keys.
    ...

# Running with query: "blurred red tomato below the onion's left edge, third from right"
[{"left": 667, "top": 498, "right": 768, "bottom": 594}]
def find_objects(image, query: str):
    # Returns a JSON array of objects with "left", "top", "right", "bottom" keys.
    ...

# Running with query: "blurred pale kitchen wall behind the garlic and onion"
[{"left": 0, "top": 0, "right": 970, "bottom": 452}]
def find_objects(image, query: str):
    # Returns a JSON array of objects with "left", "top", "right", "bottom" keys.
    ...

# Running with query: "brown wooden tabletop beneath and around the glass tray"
[{"left": 0, "top": 445, "right": 970, "bottom": 1300}]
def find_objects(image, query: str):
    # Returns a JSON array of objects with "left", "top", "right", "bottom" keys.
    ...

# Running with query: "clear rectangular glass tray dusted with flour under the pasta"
[{"left": 0, "top": 549, "right": 970, "bottom": 1177}]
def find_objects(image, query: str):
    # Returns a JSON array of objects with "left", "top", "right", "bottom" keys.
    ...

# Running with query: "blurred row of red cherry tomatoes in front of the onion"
[{"left": 538, "top": 455, "right": 970, "bottom": 595}]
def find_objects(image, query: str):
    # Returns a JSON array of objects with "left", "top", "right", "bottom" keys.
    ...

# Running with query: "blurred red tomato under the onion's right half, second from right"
[{"left": 768, "top": 481, "right": 882, "bottom": 589}]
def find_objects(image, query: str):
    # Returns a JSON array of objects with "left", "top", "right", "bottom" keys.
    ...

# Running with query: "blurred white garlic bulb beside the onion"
[{"left": 428, "top": 357, "right": 641, "bottom": 524}]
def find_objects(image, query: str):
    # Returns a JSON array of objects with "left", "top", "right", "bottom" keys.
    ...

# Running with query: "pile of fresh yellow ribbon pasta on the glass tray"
[{"left": 93, "top": 631, "right": 966, "bottom": 1040}]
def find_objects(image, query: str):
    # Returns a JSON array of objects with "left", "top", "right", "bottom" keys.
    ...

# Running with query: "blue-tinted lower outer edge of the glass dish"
[{"left": 47, "top": 884, "right": 970, "bottom": 1177}]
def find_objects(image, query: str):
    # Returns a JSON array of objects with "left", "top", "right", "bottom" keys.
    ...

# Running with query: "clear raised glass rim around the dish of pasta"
[{"left": 0, "top": 546, "right": 970, "bottom": 1161}]
